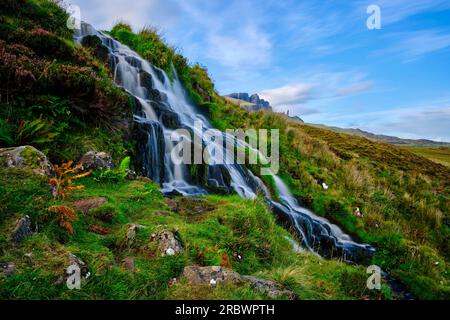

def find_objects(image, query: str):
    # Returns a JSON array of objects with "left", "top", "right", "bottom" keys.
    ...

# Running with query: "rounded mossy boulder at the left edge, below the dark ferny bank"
[{"left": 0, "top": 146, "right": 55, "bottom": 176}]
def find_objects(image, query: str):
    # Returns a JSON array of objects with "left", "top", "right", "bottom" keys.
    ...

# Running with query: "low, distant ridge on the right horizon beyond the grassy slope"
[{"left": 309, "top": 124, "right": 450, "bottom": 147}]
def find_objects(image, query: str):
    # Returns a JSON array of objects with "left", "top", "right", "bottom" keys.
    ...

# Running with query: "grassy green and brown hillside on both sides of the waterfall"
[{"left": 0, "top": 0, "right": 450, "bottom": 299}]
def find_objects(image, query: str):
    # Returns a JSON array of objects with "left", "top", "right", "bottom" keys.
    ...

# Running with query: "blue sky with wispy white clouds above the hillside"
[{"left": 69, "top": 0, "right": 450, "bottom": 141}]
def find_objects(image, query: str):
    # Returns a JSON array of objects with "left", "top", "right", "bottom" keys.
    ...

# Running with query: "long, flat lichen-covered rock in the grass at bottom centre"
[{"left": 182, "top": 266, "right": 296, "bottom": 300}]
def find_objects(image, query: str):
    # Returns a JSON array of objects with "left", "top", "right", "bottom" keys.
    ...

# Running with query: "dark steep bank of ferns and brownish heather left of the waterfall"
[{"left": 0, "top": 0, "right": 133, "bottom": 162}]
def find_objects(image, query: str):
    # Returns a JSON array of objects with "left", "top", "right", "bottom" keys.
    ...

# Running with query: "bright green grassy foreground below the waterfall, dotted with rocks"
[{"left": 0, "top": 170, "right": 388, "bottom": 299}]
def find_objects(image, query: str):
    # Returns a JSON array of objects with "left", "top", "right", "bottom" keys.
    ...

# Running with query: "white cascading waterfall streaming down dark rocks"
[{"left": 76, "top": 23, "right": 373, "bottom": 262}]
